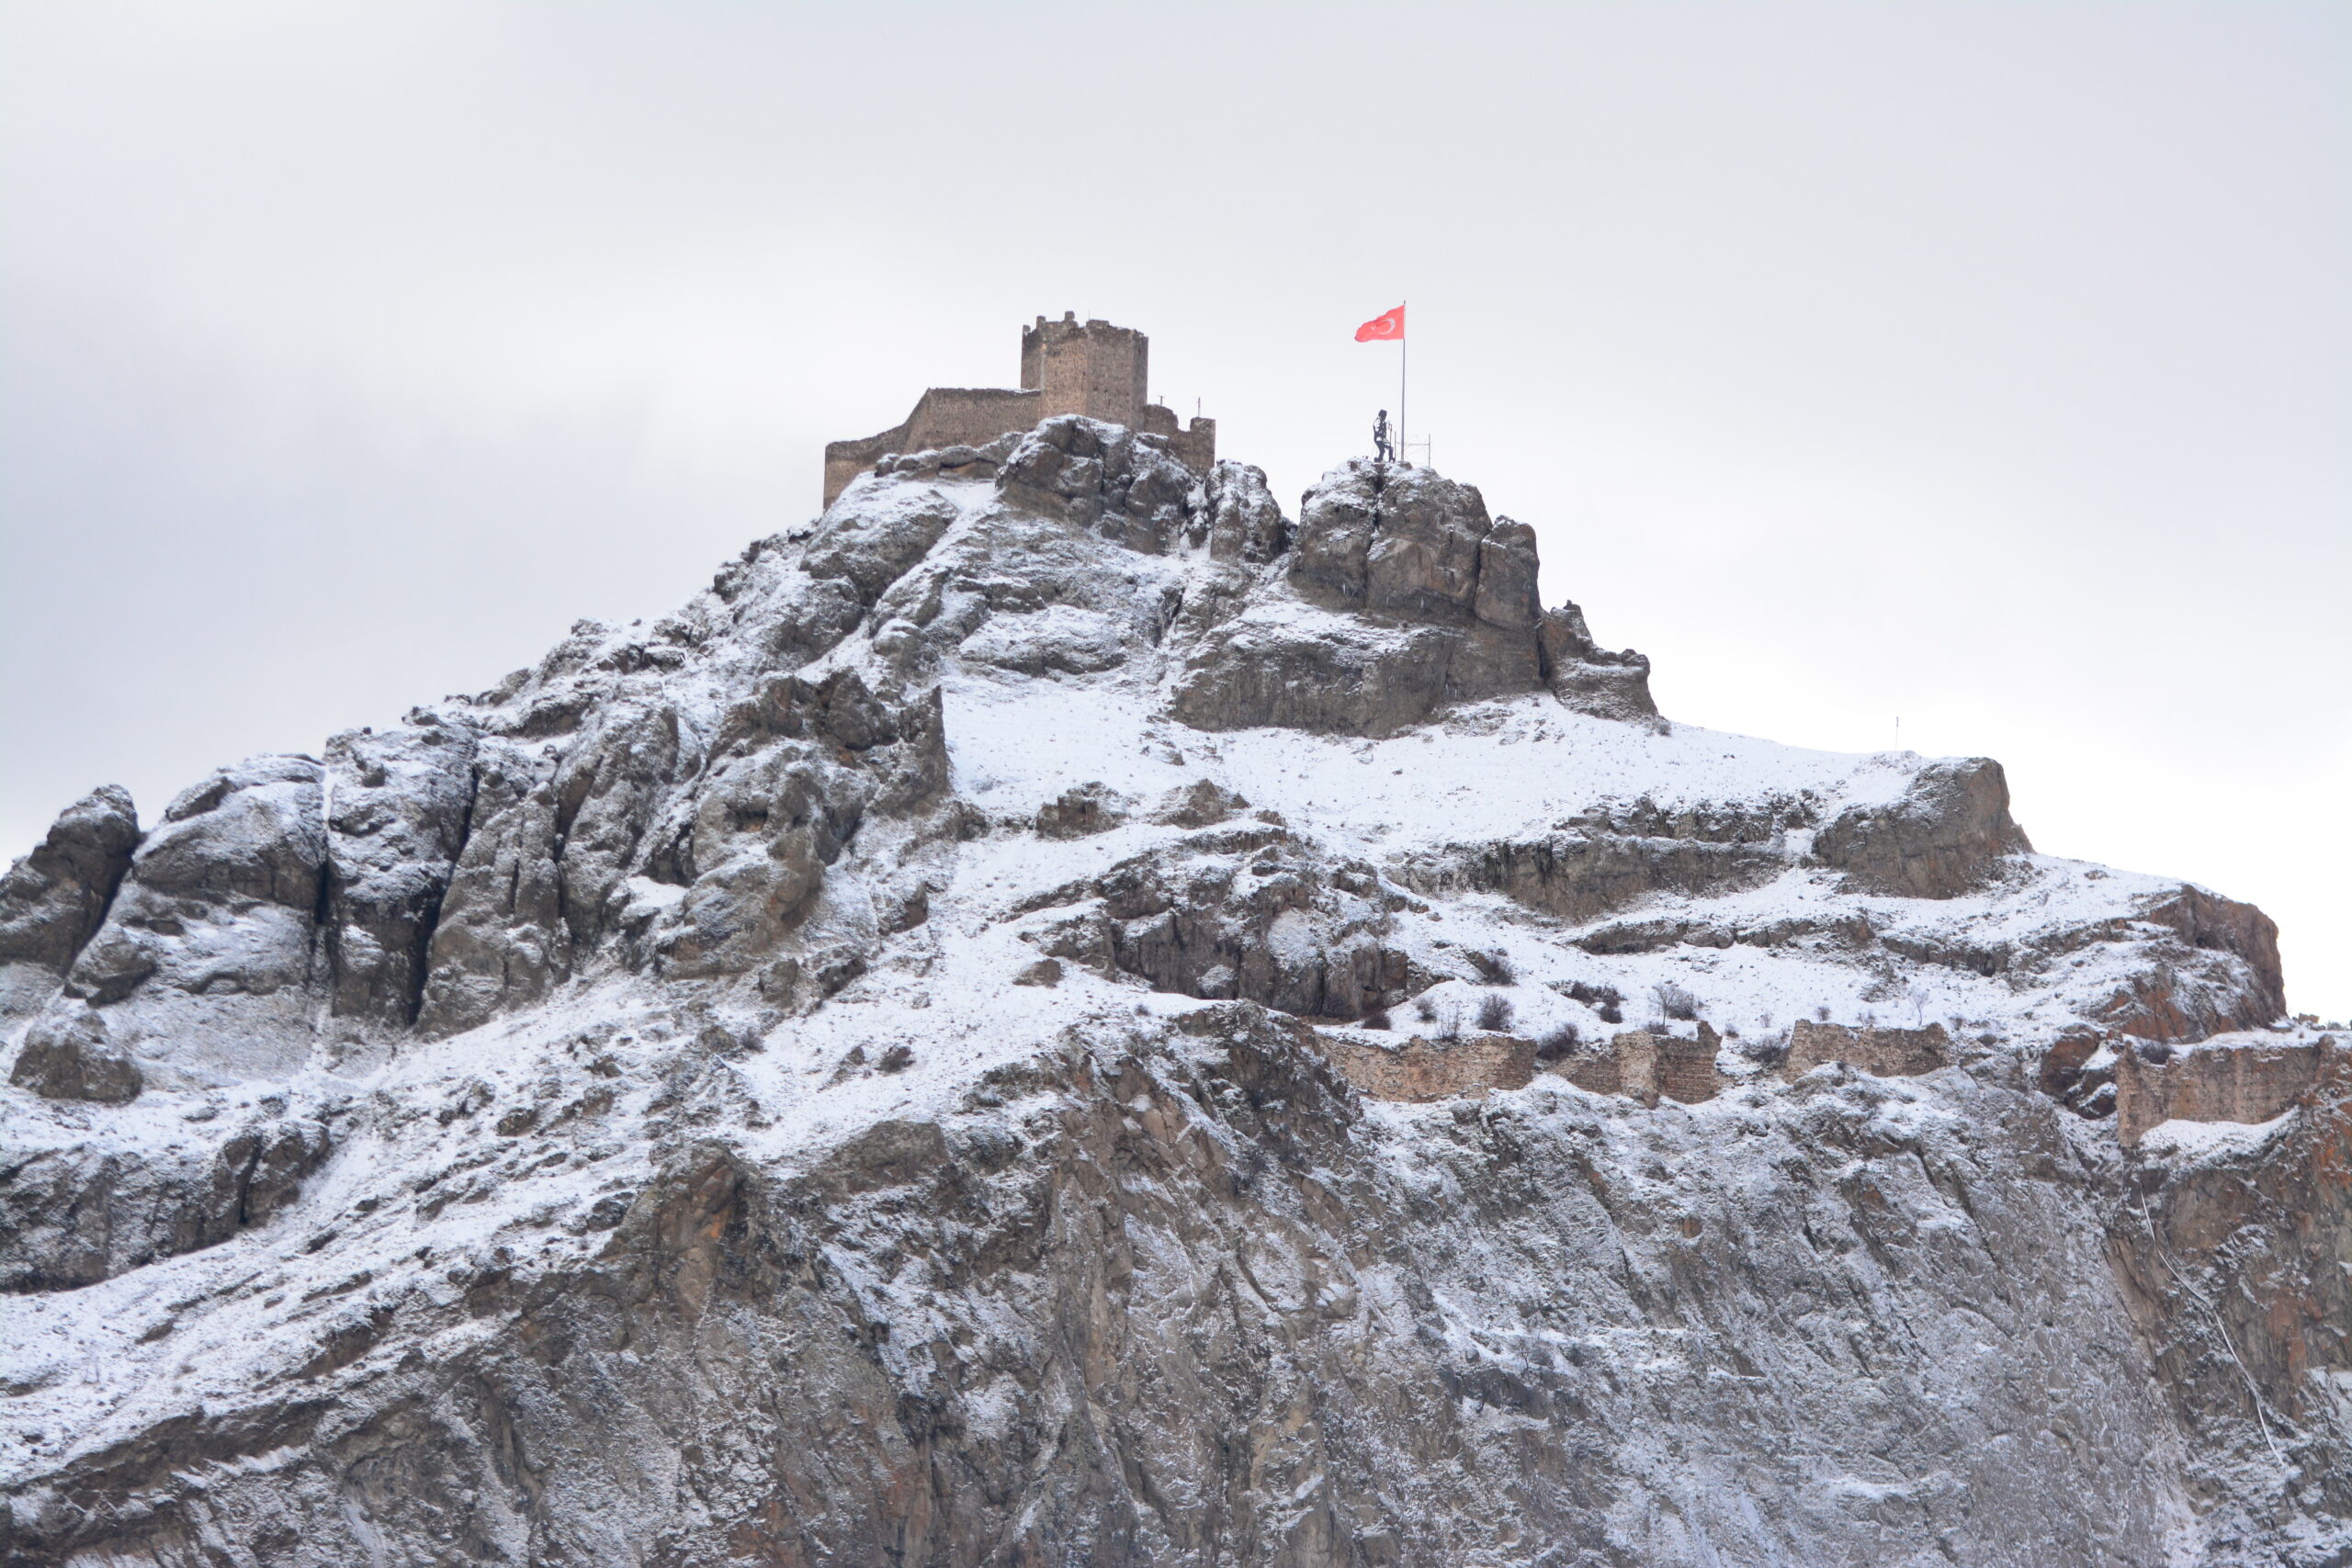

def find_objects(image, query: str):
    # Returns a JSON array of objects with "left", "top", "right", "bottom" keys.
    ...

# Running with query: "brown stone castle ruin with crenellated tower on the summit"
[{"left": 826, "top": 310, "right": 1216, "bottom": 505}]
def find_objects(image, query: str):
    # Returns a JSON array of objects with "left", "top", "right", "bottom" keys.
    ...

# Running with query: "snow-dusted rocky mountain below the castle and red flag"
[{"left": 0, "top": 419, "right": 2352, "bottom": 1565}]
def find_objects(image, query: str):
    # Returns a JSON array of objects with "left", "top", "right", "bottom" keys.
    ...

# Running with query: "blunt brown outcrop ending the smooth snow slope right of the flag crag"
[{"left": 1814, "top": 757, "right": 2032, "bottom": 898}]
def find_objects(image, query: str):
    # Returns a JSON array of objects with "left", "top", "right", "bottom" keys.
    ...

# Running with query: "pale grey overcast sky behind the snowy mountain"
[{"left": 0, "top": 0, "right": 2352, "bottom": 1018}]
